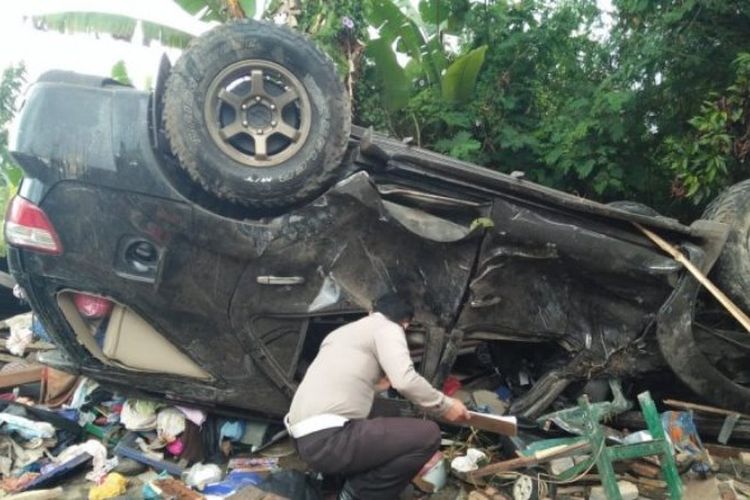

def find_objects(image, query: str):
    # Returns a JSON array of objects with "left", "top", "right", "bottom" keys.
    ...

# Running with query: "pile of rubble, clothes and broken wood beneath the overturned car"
[{"left": 0, "top": 315, "right": 750, "bottom": 500}]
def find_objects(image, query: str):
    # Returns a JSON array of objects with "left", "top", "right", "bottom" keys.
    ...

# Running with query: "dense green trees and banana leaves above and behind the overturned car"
[{"left": 26, "top": 0, "right": 750, "bottom": 219}]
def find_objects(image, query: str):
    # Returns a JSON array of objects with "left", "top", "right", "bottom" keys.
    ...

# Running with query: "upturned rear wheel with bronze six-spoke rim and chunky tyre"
[{"left": 164, "top": 20, "right": 351, "bottom": 207}]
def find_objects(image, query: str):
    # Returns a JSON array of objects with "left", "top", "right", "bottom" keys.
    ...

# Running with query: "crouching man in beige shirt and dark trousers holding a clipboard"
[{"left": 286, "top": 293, "right": 469, "bottom": 500}]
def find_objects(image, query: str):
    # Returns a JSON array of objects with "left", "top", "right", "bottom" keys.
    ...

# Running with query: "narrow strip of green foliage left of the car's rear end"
[{"left": 0, "top": 64, "right": 26, "bottom": 256}]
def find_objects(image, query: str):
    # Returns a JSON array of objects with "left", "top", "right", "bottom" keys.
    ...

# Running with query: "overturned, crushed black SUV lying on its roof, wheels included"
[{"left": 5, "top": 21, "right": 750, "bottom": 416}]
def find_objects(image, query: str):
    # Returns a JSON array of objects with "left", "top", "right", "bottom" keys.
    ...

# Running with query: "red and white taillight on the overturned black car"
[{"left": 5, "top": 196, "right": 62, "bottom": 255}]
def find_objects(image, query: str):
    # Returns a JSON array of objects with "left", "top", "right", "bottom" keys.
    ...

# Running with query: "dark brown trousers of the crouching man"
[{"left": 297, "top": 418, "right": 440, "bottom": 500}]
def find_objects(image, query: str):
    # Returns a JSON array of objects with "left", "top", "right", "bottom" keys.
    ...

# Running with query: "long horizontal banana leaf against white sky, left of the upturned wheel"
[{"left": 32, "top": 12, "right": 193, "bottom": 48}]
